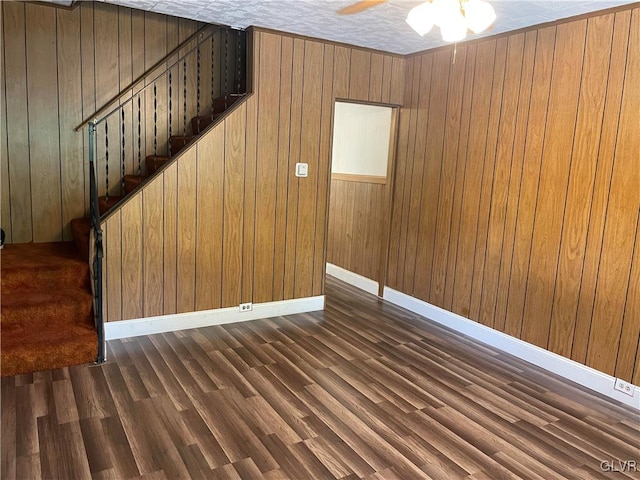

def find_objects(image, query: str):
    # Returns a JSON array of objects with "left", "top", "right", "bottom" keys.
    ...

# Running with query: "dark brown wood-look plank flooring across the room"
[{"left": 1, "top": 279, "right": 640, "bottom": 480}]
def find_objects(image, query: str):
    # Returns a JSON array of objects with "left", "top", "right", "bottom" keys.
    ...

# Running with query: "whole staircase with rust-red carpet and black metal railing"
[{"left": 0, "top": 25, "right": 247, "bottom": 376}]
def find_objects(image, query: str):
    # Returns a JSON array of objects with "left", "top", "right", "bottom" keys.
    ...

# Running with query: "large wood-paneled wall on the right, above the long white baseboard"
[{"left": 388, "top": 6, "right": 640, "bottom": 384}]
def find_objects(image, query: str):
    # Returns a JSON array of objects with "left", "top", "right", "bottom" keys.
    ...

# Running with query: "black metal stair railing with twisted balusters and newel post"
[{"left": 88, "top": 25, "right": 247, "bottom": 363}]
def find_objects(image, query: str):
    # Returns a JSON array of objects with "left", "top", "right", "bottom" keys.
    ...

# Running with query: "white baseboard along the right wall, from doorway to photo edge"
[{"left": 384, "top": 286, "right": 640, "bottom": 410}]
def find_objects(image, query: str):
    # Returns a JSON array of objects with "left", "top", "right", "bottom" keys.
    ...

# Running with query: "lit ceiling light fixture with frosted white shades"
[{"left": 407, "top": 0, "right": 496, "bottom": 42}]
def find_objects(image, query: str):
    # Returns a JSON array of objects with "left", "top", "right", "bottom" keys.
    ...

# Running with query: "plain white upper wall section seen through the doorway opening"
[{"left": 331, "top": 102, "right": 392, "bottom": 177}]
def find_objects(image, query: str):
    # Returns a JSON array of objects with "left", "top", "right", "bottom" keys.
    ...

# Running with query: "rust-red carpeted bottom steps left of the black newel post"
[{"left": 0, "top": 242, "right": 98, "bottom": 376}]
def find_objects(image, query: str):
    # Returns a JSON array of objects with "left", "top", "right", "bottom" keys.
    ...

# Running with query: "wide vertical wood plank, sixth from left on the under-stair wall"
[{"left": 195, "top": 128, "right": 225, "bottom": 310}]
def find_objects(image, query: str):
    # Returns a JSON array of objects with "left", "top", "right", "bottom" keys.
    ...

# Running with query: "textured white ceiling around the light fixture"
[{"left": 96, "top": 0, "right": 637, "bottom": 54}]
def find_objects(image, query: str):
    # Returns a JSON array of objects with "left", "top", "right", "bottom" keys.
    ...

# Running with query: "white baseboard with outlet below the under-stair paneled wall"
[{"left": 104, "top": 295, "right": 324, "bottom": 340}]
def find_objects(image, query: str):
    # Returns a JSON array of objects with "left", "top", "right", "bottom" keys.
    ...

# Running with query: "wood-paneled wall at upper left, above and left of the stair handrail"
[{"left": 0, "top": 2, "right": 200, "bottom": 243}]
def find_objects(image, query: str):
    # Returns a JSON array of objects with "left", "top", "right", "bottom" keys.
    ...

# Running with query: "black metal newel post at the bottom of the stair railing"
[{"left": 89, "top": 121, "right": 105, "bottom": 363}]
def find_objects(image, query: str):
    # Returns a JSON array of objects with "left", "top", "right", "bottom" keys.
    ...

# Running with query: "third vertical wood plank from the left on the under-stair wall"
[{"left": 142, "top": 181, "right": 164, "bottom": 317}]
